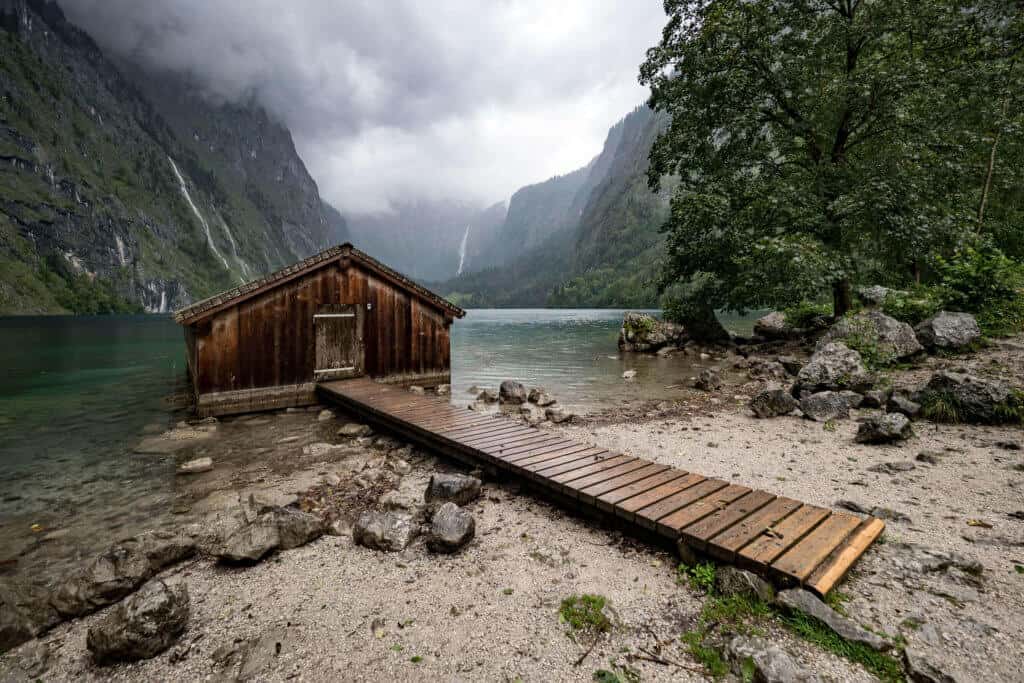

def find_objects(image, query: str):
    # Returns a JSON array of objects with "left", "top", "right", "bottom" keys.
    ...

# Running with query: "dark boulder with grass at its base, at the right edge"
[{"left": 913, "top": 371, "right": 1024, "bottom": 424}]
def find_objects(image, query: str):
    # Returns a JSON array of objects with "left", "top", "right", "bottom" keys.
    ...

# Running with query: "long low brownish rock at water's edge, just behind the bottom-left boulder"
[{"left": 50, "top": 531, "right": 196, "bottom": 617}]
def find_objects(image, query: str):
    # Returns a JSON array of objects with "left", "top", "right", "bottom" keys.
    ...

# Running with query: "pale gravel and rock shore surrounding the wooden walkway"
[{"left": 0, "top": 313, "right": 1024, "bottom": 681}]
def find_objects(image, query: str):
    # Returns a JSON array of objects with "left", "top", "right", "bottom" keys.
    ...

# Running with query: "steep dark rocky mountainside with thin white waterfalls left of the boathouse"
[{"left": 0, "top": 0, "right": 335, "bottom": 313}]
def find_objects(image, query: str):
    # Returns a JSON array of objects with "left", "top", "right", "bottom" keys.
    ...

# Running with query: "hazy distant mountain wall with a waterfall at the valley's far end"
[{"left": 346, "top": 200, "right": 505, "bottom": 281}]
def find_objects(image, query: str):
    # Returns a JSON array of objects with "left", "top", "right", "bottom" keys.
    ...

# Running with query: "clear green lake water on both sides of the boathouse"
[{"left": 0, "top": 309, "right": 753, "bottom": 573}]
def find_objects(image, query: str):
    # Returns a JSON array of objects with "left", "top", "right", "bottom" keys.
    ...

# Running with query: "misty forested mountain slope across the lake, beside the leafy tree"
[{"left": 437, "top": 106, "right": 675, "bottom": 307}]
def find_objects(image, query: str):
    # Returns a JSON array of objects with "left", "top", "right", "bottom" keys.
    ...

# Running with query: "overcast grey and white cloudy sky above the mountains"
[{"left": 60, "top": 0, "right": 665, "bottom": 212}]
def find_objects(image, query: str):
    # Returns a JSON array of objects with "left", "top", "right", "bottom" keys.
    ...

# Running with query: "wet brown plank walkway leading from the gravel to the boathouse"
[{"left": 317, "top": 378, "right": 885, "bottom": 596}]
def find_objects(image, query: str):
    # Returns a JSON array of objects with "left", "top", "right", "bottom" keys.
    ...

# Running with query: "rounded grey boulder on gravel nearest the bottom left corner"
[{"left": 86, "top": 579, "right": 189, "bottom": 664}]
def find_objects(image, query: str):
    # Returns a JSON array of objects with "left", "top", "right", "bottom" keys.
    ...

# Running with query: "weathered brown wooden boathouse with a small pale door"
[{"left": 174, "top": 243, "right": 465, "bottom": 417}]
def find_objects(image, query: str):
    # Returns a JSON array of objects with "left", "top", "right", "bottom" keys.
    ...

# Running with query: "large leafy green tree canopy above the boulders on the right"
[{"left": 640, "top": 0, "right": 1021, "bottom": 314}]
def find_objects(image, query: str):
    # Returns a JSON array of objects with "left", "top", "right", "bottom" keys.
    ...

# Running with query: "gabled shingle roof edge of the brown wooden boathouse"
[{"left": 174, "top": 242, "right": 466, "bottom": 325}]
